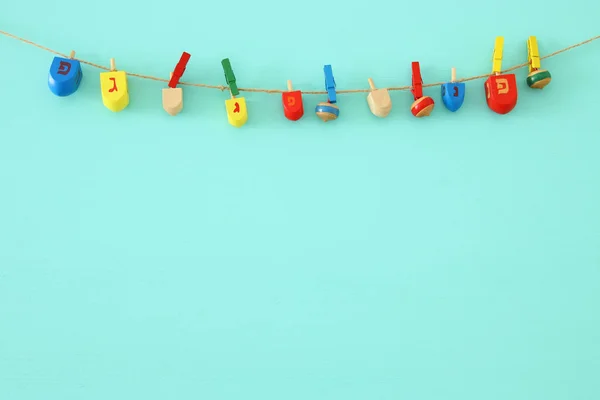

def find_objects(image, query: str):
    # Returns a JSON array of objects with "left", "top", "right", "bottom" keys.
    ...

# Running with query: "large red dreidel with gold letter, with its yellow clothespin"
[{"left": 484, "top": 36, "right": 517, "bottom": 114}]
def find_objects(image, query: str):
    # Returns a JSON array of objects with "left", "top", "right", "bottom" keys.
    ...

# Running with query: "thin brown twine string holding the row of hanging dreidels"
[{"left": 0, "top": 30, "right": 600, "bottom": 94}]
